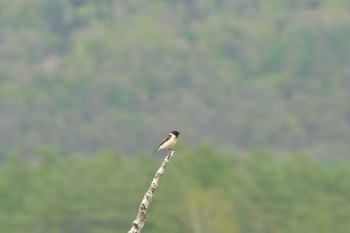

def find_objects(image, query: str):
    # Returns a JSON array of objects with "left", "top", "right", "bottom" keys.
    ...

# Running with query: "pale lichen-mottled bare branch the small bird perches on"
[{"left": 128, "top": 150, "right": 175, "bottom": 233}]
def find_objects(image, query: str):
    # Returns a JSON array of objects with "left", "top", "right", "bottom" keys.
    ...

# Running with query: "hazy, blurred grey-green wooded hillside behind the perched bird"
[{"left": 0, "top": 0, "right": 350, "bottom": 161}]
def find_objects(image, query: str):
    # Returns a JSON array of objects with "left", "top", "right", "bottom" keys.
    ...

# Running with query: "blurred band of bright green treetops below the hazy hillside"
[{"left": 0, "top": 145, "right": 350, "bottom": 233}]
